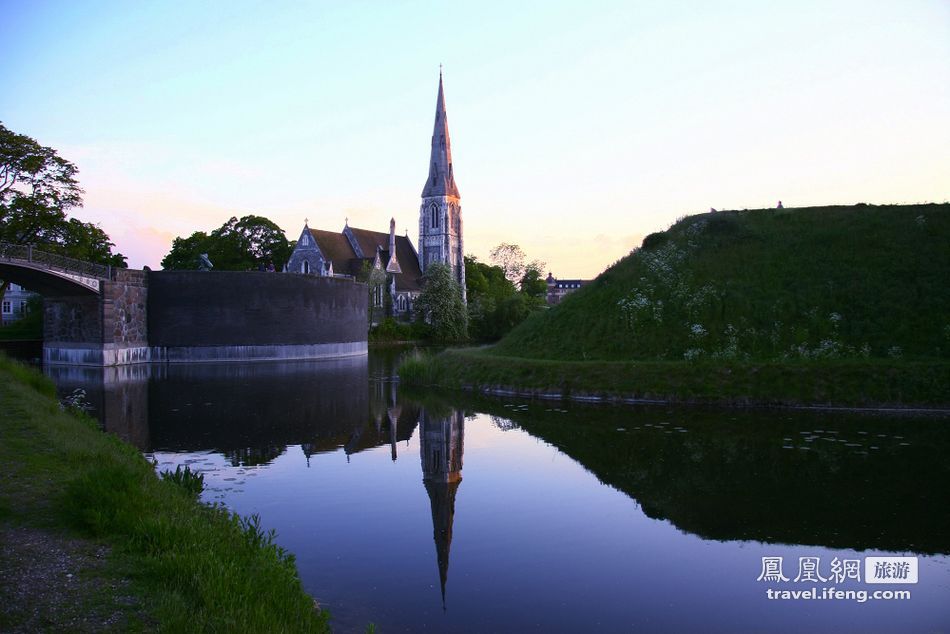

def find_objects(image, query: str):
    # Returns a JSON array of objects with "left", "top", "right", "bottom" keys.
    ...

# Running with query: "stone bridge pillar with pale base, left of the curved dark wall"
[{"left": 43, "top": 269, "right": 151, "bottom": 366}]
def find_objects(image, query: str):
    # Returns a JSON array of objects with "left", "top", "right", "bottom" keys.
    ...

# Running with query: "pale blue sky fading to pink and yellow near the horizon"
[{"left": 0, "top": 0, "right": 950, "bottom": 278}]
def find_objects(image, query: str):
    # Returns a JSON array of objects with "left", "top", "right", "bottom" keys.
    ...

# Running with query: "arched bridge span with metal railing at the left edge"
[{"left": 0, "top": 242, "right": 115, "bottom": 295}]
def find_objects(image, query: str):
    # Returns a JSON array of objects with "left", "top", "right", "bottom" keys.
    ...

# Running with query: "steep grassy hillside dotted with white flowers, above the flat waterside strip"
[{"left": 494, "top": 203, "right": 950, "bottom": 361}]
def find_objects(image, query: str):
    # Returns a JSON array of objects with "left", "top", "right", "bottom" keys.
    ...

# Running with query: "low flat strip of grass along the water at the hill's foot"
[{"left": 399, "top": 348, "right": 950, "bottom": 408}]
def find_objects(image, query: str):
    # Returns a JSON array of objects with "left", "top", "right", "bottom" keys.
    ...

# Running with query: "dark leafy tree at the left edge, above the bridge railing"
[{"left": 0, "top": 123, "right": 126, "bottom": 267}]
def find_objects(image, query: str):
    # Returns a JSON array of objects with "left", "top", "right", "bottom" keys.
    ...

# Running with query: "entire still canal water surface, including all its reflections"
[{"left": 46, "top": 352, "right": 950, "bottom": 632}]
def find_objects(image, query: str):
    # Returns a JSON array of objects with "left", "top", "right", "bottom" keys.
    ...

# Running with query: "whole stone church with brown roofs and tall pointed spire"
[{"left": 284, "top": 72, "right": 465, "bottom": 318}]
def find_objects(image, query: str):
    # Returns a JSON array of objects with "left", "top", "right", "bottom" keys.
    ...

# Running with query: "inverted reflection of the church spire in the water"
[{"left": 419, "top": 410, "right": 465, "bottom": 610}]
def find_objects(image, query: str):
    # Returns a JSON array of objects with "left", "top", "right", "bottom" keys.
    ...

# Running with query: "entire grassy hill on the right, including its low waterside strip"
[{"left": 401, "top": 203, "right": 950, "bottom": 408}]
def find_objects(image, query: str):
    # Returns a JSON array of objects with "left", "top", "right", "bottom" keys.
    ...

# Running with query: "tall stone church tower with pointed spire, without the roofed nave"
[{"left": 419, "top": 70, "right": 465, "bottom": 301}]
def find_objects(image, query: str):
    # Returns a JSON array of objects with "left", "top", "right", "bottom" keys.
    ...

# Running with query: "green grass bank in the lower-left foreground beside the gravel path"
[{"left": 0, "top": 357, "right": 328, "bottom": 632}]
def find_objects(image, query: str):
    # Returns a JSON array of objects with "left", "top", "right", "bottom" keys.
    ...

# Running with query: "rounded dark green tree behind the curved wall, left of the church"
[{"left": 162, "top": 215, "right": 294, "bottom": 271}]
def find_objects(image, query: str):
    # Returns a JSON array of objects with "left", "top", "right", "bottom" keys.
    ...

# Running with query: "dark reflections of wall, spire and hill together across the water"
[{"left": 46, "top": 354, "right": 950, "bottom": 556}]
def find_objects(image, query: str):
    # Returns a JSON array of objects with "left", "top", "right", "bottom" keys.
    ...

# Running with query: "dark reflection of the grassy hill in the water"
[{"left": 444, "top": 390, "right": 950, "bottom": 553}]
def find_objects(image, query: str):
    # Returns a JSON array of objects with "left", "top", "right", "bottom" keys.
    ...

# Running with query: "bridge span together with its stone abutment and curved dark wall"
[{"left": 0, "top": 242, "right": 369, "bottom": 366}]
